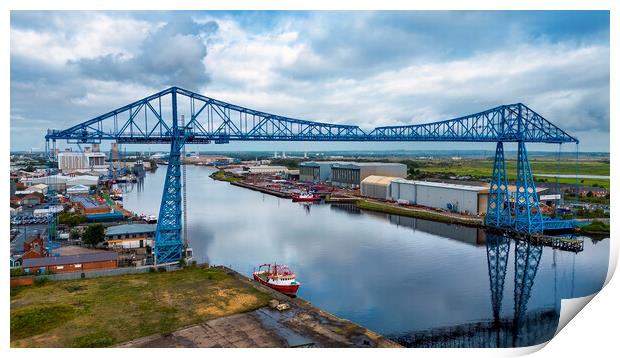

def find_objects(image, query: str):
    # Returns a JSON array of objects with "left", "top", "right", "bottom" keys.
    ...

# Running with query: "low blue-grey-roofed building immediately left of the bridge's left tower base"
[{"left": 105, "top": 224, "right": 157, "bottom": 249}]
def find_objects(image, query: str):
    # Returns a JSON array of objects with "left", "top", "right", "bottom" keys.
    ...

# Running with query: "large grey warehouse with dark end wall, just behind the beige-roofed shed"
[{"left": 331, "top": 162, "right": 407, "bottom": 188}]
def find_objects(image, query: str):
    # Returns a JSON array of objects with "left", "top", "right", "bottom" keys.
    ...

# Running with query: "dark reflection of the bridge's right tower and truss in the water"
[{"left": 392, "top": 230, "right": 559, "bottom": 347}]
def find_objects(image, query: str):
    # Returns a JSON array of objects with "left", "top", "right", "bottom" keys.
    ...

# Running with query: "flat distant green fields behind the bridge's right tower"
[{"left": 419, "top": 160, "right": 610, "bottom": 188}]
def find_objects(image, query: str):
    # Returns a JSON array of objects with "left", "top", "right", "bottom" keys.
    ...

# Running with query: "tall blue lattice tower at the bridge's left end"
[{"left": 154, "top": 88, "right": 185, "bottom": 265}]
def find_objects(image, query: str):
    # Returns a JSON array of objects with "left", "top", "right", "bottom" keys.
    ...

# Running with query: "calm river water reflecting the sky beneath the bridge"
[{"left": 125, "top": 166, "right": 609, "bottom": 346}]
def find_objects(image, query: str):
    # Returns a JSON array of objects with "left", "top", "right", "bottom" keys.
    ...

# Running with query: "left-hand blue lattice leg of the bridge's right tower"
[{"left": 485, "top": 142, "right": 512, "bottom": 228}]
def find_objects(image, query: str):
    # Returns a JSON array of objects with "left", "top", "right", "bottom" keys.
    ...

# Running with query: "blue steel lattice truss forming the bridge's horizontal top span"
[{"left": 46, "top": 87, "right": 578, "bottom": 143}]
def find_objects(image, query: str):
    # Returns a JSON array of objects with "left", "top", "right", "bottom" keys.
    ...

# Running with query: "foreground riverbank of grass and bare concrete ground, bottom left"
[{"left": 11, "top": 267, "right": 398, "bottom": 347}]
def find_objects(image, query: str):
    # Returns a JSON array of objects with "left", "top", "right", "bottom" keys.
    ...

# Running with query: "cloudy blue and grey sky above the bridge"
[{"left": 11, "top": 11, "right": 610, "bottom": 151}]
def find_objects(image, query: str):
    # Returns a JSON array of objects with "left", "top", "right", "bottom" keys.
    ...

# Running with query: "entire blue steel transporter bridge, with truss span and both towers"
[{"left": 45, "top": 87, "right": 578, "bottom": 263}]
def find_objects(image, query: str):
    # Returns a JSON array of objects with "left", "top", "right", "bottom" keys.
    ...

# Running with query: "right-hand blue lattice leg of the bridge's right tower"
[{"left": 513, "top": 142, "right": 544, "bottom": 234}]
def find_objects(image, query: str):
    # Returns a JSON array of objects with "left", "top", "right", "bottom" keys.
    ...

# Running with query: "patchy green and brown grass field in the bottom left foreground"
[{"left": 11, "top": 267, "right": 270, "bottom": 347}]
